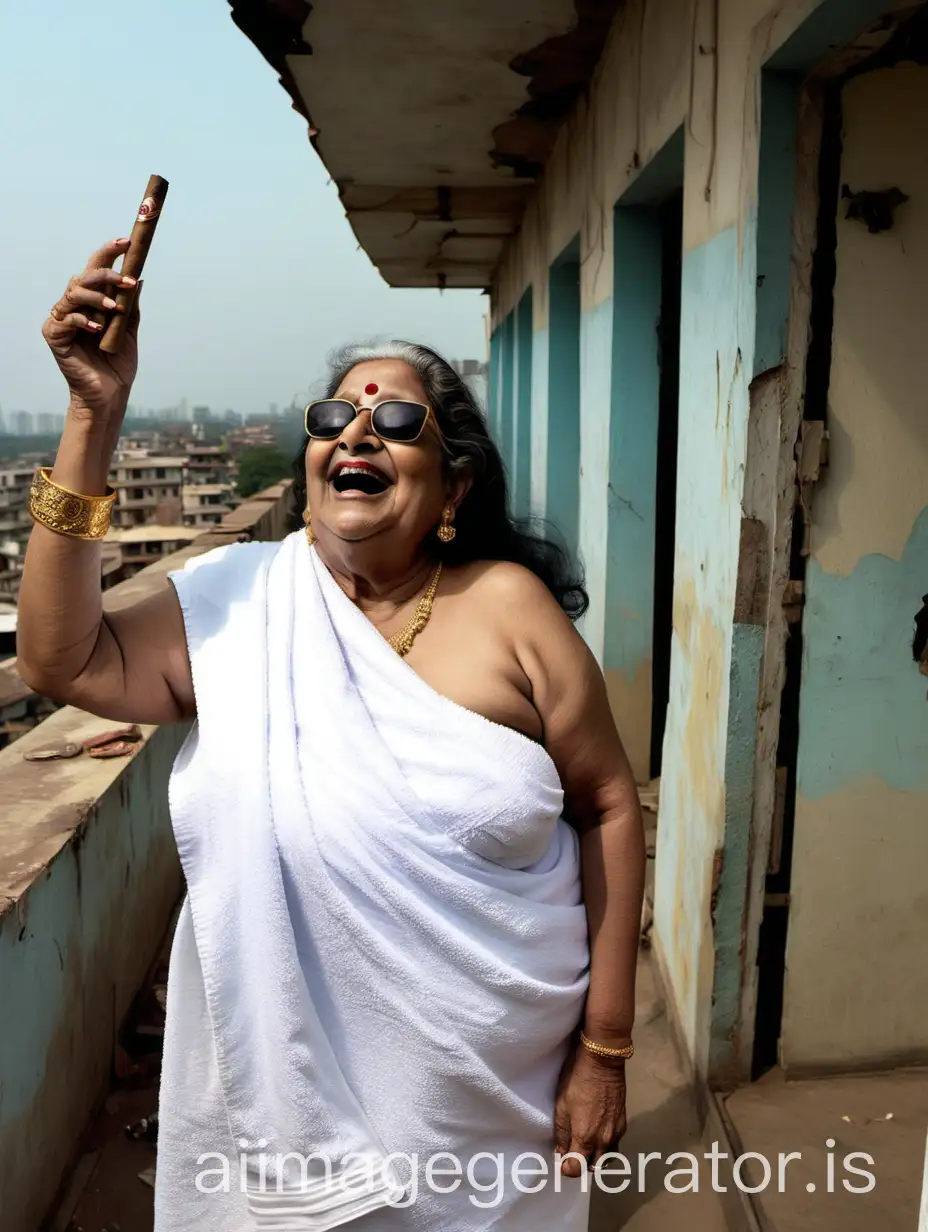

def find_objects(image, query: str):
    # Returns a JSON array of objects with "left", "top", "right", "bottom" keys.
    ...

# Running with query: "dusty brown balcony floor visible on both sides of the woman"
[{"left": 51, "top": 788, "right": 928, "bottom": 1232}]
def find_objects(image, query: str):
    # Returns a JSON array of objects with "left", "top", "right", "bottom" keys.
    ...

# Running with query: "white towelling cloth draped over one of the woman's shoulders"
[{"left": 155, "top": 532, "right": 588, "bottom": 1232}]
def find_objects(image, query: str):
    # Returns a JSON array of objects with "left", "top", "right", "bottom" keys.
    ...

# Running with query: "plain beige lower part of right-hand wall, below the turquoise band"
[{"left": 781, "top": 774, "right": 928, "bottom": 1072}]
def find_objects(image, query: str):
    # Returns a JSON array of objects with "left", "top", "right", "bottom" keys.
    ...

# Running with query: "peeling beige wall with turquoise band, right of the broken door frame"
[{"left": 781, "top": 64, "right": 928, "bottom": 1071}]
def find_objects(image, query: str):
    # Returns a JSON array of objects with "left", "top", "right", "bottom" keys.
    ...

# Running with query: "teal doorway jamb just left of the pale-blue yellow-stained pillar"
[{"left": 604, "top": 207, "right": 662, "bottom": 694}]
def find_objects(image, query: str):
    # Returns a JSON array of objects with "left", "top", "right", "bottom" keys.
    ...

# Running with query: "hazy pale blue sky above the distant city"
[{"left": 0, "top": 0, "right": 487, "bottom": 413}]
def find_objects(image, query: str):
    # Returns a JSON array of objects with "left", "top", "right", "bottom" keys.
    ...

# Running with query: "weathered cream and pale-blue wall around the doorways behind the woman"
[{"left": 493, "top": 0, "right": 911, "bottom": 1072}]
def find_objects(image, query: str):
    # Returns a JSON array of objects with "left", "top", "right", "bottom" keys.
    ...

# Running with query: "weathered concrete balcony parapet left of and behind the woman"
[{"left": 0, "top": 483, "right": 291, "bottom": 1232}]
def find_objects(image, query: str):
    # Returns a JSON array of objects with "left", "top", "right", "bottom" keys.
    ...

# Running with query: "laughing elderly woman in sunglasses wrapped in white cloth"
[{"left": 18, "top": 240, "right": 643, "bottom": 1232}]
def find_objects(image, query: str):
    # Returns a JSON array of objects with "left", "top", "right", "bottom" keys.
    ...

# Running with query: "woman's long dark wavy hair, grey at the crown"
[{"left": 292, "top": 341, "right": 589, "bottom": 620}]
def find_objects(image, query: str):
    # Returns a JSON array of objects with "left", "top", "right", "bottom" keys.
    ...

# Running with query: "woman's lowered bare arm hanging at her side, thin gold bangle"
[{"left": 518, "top": 579, "right": 646, "bottom": 1175}]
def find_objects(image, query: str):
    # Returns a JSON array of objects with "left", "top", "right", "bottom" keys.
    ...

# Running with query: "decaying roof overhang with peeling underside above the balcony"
[{"left": 229, "top": 0, "right": 621, "bottom": 287}]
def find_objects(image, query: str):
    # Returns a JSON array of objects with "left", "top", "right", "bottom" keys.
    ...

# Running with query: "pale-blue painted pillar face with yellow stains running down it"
[{"left": 654, "top": 219, "right": 755, "bottom": 1072}]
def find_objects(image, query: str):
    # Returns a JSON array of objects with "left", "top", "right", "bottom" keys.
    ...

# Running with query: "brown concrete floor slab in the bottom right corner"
[{"left": 725, "top": 1069, "right": 928, "bottom": 1232}]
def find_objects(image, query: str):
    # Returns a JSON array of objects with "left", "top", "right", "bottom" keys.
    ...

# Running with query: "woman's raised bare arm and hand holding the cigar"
[{"left": 16, "top": 239, "right": 195, "bottom": 723}]
